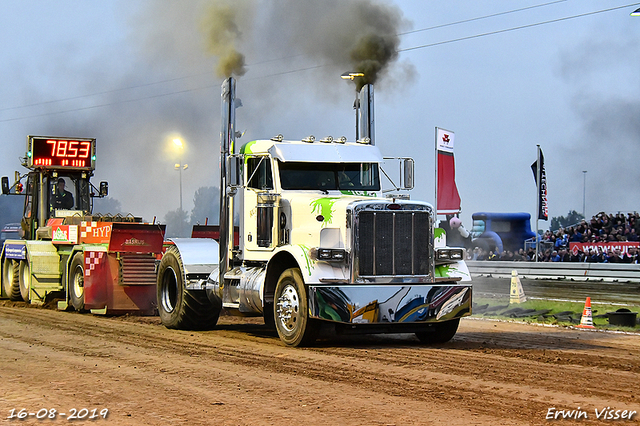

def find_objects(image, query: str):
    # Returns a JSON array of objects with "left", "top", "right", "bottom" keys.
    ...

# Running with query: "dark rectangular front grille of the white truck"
[{"left": 356, "top": 210, "right": 432, "bottom": 276}]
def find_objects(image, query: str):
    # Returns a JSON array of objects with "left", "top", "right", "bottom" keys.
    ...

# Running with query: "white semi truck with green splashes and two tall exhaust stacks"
[{"left": 157, "top": 78, "right": 472, "bottom": 346}]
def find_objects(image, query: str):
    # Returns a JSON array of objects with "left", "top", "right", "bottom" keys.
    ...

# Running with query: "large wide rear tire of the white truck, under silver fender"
[{"left": 157, "top": 247, "right": 222, "bottom": 330}]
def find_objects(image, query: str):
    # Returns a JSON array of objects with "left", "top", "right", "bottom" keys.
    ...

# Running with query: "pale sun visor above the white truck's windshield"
[{"left": 269, "top": 142, "right": 382, "bottom": 163}]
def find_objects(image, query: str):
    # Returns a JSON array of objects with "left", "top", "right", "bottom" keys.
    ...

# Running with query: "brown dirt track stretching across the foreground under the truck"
[{"left": 0, "top": 306, "right": 640, "bottom": 426}]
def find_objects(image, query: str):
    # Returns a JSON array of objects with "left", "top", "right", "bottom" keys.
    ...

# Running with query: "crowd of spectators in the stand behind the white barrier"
[{"left": 467, "top": 212, "right": 640, "bottom": 263}]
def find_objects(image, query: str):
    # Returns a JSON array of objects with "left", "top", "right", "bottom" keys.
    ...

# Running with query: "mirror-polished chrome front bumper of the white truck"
[{"left": 309, "top": 284, "right": 472, "bottom": 325}]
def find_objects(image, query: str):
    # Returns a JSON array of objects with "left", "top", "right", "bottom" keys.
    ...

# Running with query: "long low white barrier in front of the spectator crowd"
[{"left": 467, "top": 260, "right": 640, "bottom": 283}]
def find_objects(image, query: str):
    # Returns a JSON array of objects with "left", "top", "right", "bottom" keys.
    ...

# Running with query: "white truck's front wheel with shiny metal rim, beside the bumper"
[{"left": 274, "top": 268, "right": 319, "bottom": 346}]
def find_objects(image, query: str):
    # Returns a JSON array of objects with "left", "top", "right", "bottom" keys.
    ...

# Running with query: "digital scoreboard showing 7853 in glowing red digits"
[{"left": 27, "top": 136, "right": 96, "bottom": 170}]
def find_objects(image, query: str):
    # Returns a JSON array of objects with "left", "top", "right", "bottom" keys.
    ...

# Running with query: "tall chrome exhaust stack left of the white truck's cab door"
[{"left": 218, "top": 77, "right": 236, "bottom": 288}]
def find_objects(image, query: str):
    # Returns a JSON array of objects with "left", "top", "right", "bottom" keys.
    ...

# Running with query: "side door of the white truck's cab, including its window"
[{"left": 243, "top": 155, "right": 277, "bottom": 251}]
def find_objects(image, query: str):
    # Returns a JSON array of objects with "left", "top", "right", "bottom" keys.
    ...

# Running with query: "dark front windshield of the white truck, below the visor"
[{"left": 278, "top": 162, "right": 380, "bottom": 191}]
